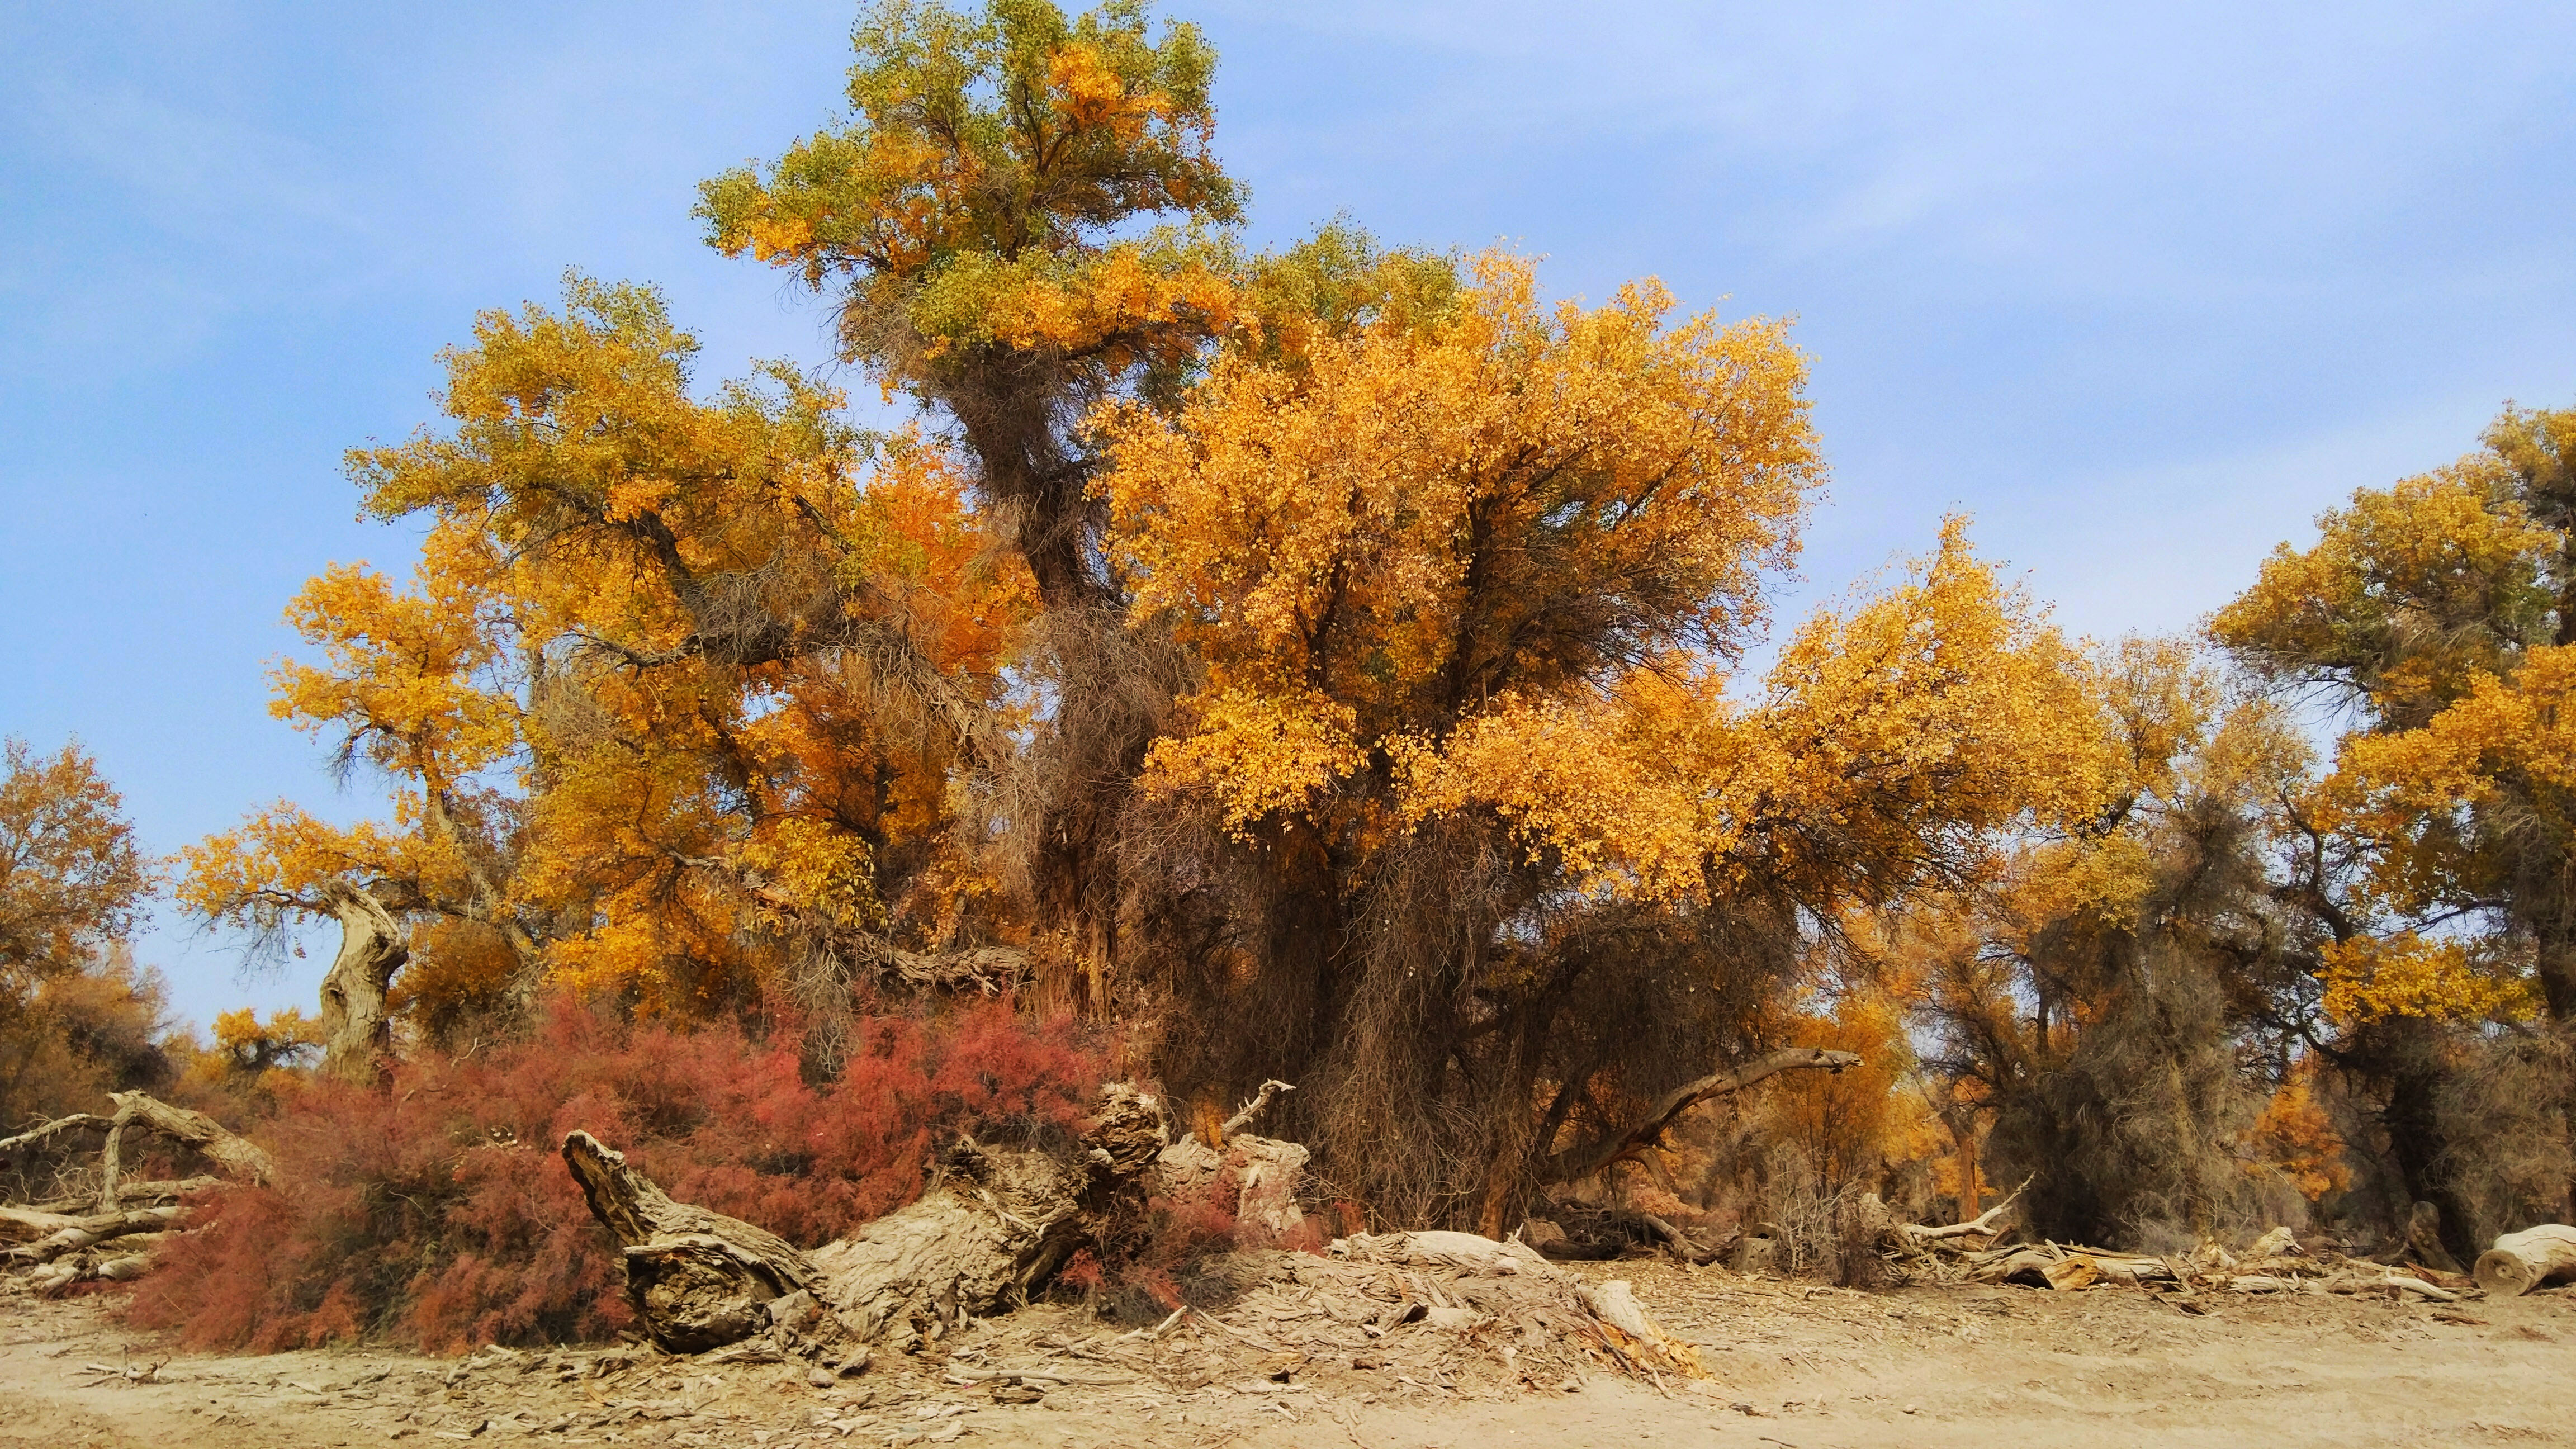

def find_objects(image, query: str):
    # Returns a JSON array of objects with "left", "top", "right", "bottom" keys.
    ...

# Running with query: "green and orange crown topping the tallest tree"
[{"left": 698, "top": 3, "right": 1239, "bottom": 392}]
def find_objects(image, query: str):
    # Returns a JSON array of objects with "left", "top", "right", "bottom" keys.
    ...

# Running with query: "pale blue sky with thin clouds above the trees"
[{"left": 0, "top": 0, "right": 2576, "bottom": 1021}]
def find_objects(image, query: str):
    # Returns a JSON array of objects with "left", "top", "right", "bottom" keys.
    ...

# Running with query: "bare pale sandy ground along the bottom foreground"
[{"left": 0, "top": 1263, "right": 2576, "bottom": 1449}]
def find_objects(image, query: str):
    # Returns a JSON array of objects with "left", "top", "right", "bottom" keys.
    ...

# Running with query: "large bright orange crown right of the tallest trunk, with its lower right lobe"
[{"left": 1097, "top": 255, "right": 2113, "bottom": 917}]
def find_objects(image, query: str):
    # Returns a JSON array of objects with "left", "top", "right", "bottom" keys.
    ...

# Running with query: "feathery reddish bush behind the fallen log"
[{"left": 131, "top": 1003, "right": 1107, "bottom": 1351}]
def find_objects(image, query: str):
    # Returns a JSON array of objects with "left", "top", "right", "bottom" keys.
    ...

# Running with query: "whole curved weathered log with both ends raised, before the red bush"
[{"left": 564, "top": 1086, "right": 1164, "bottom": 1353}]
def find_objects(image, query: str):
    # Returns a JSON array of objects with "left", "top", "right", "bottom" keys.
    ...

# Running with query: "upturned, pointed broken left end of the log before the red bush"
[{"left": 564, "top": 1132, "right": 817, "bottom": 1353}]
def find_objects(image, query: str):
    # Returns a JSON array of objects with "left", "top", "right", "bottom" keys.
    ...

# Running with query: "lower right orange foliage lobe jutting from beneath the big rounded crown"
[{"left": 1407, "top": 528, "right": 2107, "bottom": 902}]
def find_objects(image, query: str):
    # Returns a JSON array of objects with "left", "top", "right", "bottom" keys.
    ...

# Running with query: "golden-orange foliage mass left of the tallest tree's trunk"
[{"left": 183, "top": 278, "right": 1030, "bottom": 1019}]
